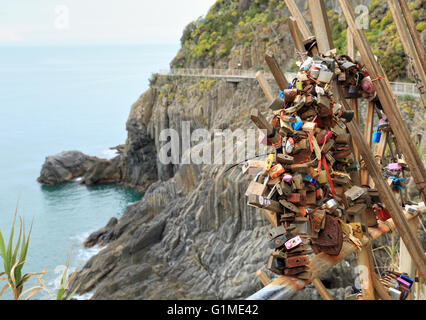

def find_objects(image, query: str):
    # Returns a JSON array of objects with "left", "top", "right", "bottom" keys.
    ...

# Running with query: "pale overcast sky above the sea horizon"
[{"left": 0, "top": 0, "right": 216, "bottom": 45}]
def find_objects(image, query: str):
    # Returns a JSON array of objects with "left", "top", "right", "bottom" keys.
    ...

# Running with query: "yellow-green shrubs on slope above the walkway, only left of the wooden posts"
[{"left": 172, "top": 0, "right": 287, "bottom": 68}]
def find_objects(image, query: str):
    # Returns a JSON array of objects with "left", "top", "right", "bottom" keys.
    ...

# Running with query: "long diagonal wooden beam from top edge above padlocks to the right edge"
[{"left": 338, "top": 0, "right": 426, "bottom": 204}]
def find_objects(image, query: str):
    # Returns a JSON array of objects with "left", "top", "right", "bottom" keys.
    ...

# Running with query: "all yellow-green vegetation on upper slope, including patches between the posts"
[{"left": 171, "top": 0, "right": 426, "bottom": 80}]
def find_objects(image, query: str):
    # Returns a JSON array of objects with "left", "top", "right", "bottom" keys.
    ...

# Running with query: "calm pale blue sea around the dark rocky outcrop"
[{"left": 0, "top": 44, "right": 178, "bottom": 299}]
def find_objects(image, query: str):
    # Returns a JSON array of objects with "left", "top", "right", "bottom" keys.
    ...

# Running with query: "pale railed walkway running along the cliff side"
[{"left": 158, "top": 68, "right": 420, "bottom": 97}]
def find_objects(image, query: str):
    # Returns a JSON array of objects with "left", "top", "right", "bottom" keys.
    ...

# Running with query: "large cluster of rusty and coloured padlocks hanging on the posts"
[{"left": 243, "top": 46, "right": 422, "bottom": 279}]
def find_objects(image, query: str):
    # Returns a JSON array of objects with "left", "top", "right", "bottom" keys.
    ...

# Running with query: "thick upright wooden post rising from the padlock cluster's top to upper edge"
[{"left": 308, "top": 0, "right": 334, "bottom": 53}]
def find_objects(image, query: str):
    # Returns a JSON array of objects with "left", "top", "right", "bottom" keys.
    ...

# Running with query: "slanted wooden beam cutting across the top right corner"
[{"left": 388, "top": 0, "right": 426, "bottom": 106}]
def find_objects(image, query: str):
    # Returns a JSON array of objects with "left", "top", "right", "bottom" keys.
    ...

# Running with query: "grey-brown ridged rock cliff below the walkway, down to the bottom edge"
[{"left": 70, "top": 79, "right": 282, "bottom": 299}]
